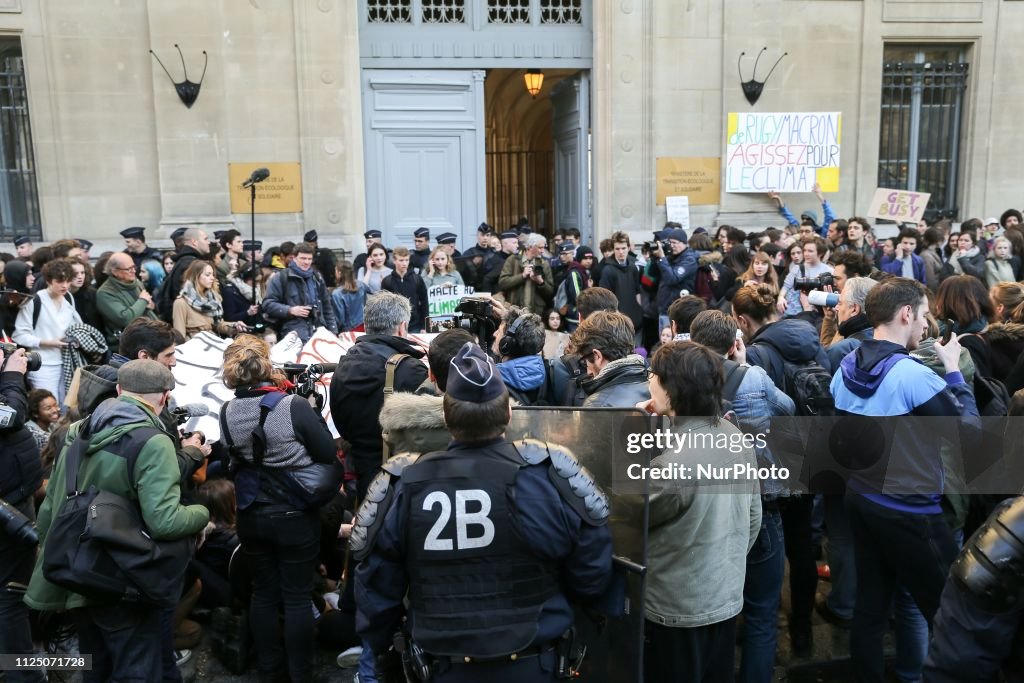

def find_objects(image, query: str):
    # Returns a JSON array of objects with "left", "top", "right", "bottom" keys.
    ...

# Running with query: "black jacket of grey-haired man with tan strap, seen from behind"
[{"left": 331, "top": 335, "right": 427, "bottom": 483}]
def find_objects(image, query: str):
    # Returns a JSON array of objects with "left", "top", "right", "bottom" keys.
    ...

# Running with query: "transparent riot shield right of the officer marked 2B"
[{"left": 506, "top": 408, "right": 651, "bottom": 683}]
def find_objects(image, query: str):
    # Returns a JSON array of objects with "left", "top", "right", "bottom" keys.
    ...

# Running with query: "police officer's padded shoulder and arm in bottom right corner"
[{"left": 924, "top": 496, "right": 1024, "bottom": 683}]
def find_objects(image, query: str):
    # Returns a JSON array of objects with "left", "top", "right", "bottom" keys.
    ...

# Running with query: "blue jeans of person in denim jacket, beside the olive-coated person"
[{"left": 736, "top": 509, "right": 785, "bottom": 683}]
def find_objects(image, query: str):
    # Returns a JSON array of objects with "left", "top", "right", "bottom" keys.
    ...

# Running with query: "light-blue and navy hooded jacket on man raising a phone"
[{"left": 831, "top": 339, "right": 978, "bottom": 514}]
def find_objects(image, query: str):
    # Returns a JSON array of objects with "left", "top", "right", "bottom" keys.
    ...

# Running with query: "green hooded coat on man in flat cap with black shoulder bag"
[{"left": 25, "top": 396, "right": 210, "bottom": 610}]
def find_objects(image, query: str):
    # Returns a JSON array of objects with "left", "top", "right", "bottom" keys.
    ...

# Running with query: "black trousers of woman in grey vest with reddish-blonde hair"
[{"left": 238, "top": 505, "right": 319, "bottom": 683}]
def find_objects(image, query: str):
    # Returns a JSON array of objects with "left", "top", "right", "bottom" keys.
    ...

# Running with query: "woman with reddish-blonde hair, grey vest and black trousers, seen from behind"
[{"left": 220, "top": 335, "right": 342, "bottom": 681}]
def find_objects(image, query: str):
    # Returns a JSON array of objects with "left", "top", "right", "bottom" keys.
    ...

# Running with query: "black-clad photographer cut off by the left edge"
[{"left": 0, "top": 349, "right": 46, "bottom": 683}]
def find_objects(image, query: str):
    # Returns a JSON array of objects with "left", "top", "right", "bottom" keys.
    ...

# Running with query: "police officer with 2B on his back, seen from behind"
[{"left": 349, "top": 342, "right": 611, "bottom": 683}]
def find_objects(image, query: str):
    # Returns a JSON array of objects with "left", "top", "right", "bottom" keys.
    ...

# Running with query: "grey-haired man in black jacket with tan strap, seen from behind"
[{"left": 331, "top": 292, "right": 423, "bottom": 500}]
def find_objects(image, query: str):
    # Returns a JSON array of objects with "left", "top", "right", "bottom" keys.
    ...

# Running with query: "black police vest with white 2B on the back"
[{"left": 401, "top": 443, "right": 559, "bottom": 658}]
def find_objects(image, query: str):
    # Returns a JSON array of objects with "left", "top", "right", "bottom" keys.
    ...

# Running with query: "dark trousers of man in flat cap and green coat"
[{"left": 74, "top": 605, "right": 163, "bottom": 683}]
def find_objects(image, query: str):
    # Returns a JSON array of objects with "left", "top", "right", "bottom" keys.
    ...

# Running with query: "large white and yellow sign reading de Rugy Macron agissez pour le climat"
[{"left": 725, "top": 112, "right": 842, "bottom": 193}]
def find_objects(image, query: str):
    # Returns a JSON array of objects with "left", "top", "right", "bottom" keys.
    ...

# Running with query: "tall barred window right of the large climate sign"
[{"left": 879, "top": 45, "right": 968, "bottom": 220}]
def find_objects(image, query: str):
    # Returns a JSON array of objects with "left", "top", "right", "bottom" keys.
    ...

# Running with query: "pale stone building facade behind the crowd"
[{"left": 0, "top": 0, "right": 1024, "bottom": 249}]
